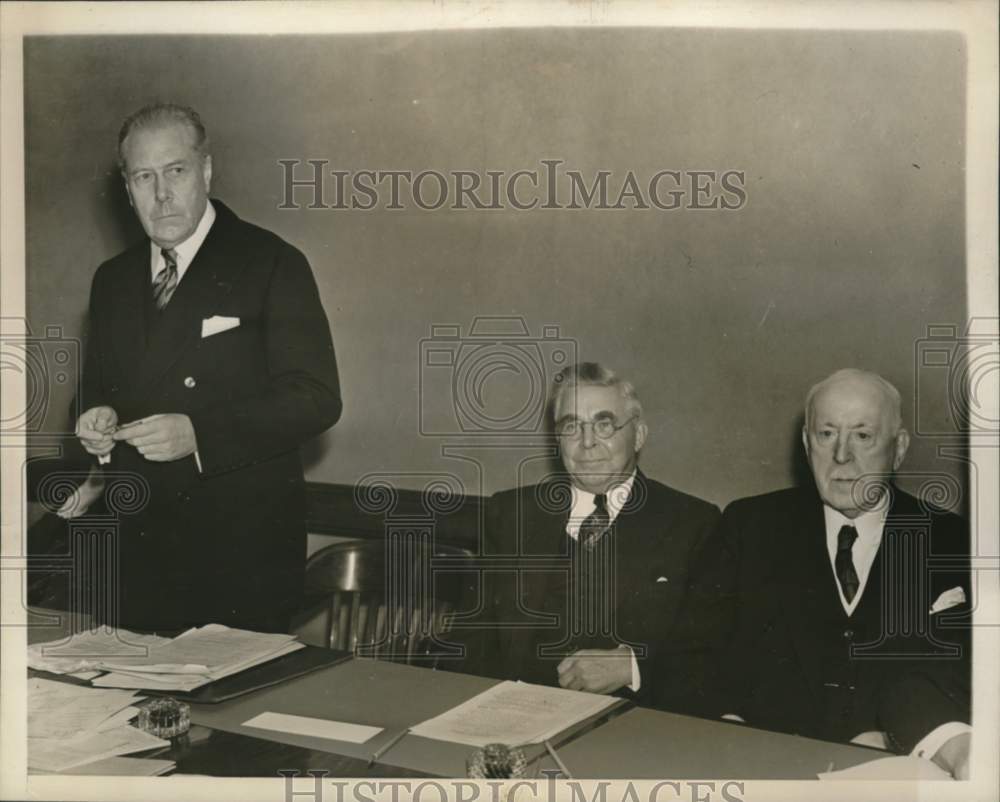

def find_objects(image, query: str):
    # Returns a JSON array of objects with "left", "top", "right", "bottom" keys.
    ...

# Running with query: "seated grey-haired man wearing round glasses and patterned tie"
[{"left": 465, "top": 362, "right": 719, "bottom": 702}]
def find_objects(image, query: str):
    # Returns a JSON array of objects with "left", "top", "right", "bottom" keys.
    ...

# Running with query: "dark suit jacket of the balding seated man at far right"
[{"left": 705, "top": 488, "right": 972, "bottom": 752}]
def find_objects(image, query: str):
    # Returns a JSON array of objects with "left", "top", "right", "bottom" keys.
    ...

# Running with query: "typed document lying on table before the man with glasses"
[{"left": 410, "top": 682, "right": 620, "bottom": 746}]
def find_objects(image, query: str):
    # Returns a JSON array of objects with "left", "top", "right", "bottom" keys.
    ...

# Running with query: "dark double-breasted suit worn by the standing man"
[{"left": 79, "top": 201, "right": 341, "bottom": 628}]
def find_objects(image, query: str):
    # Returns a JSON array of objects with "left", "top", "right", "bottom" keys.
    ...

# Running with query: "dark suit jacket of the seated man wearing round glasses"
[{"left": 467, "top": 471, "right": 719, "bottom": 702}]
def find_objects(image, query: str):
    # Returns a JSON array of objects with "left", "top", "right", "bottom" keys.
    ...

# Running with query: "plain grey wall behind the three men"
[{"left": 24, "top": 29, "right": 966, "bottom": 505}]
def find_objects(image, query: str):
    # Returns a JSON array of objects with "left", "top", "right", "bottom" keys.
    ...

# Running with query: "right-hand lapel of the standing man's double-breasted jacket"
[{"left": 125, "top": 201, "right": 244, "bottom": 396}]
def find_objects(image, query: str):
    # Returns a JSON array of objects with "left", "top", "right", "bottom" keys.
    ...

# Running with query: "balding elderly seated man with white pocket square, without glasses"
[{"left": 705, "top": 370, "right": 971, "bottom": 776}]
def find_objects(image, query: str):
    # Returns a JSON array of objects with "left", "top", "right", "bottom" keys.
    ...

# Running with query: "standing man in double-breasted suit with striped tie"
[{"left": 77, "top": 104, "right": 341, "bottom": 630}]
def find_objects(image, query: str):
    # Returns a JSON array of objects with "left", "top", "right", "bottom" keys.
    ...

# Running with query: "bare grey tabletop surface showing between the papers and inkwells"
[{"left": 29, "top": 608, "right": 885, "bottom": 779}]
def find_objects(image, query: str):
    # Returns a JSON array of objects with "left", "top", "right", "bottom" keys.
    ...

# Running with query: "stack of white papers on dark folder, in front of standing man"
[{"left": 93, "top": 624, "right": 305, "bottom": 691}]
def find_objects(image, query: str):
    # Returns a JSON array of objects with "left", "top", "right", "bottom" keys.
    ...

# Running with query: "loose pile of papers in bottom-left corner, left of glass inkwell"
[{"left": 28, "top": 677, "right": 170, "bottom": 771}]
